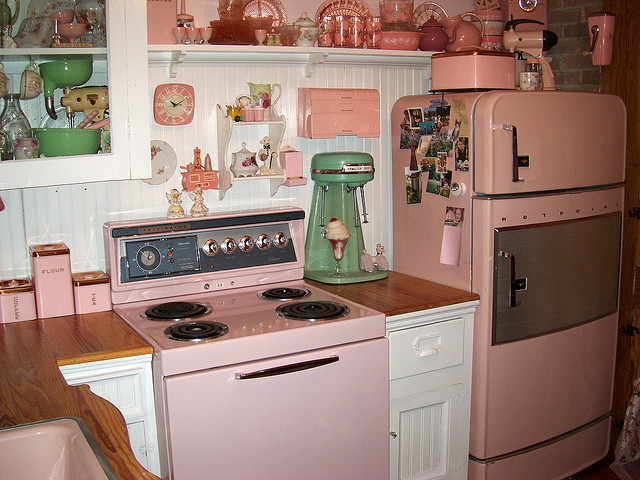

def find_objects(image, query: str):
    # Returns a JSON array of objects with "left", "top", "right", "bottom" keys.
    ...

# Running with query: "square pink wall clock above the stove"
[{"left": 153, "top": 83, "right": 195, "bottom": 125}]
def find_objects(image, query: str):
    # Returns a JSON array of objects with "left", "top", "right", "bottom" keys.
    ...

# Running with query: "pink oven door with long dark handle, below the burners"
[{"left": 164, "top": 339, "right": 389, "bottom": 480}]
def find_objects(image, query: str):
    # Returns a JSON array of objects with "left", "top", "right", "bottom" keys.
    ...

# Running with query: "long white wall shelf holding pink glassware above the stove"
[{"left": 148, "top": 44, "right": 433, "bottom": 77}]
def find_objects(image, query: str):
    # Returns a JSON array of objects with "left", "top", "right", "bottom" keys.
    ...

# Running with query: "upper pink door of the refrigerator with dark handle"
[{"left": 472, "top": 91, "right": 626, "bottom": 195}]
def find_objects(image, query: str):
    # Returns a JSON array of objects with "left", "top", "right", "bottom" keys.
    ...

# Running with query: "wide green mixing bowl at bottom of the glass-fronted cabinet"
[{"left": 32, "top": 128, "right": 100, "bottom": 157}]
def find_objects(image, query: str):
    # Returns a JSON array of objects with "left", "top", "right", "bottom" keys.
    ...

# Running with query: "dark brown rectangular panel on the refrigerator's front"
[{"left": 492, "top": 213, "right": 622, "bottom": 344}]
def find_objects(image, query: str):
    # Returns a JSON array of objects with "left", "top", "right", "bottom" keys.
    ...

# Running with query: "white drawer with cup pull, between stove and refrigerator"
[{"left": 388, "top": 318, "right": 464, "bottom": 379}]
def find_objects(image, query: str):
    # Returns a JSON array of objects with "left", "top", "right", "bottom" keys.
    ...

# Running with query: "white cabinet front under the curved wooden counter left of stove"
[{"left": 60, "top": 355, "right": 160, "bottom": 476}]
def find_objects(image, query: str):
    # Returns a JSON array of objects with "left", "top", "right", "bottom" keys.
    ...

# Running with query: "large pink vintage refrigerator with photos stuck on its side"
[{"left": 392, "top": 91, "right": 626, "bottom": 480}]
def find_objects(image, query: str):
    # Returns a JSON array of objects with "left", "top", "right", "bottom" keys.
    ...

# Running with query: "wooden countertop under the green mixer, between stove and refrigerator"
[{"left": 305, "top": 271, "right": 480, "bottom": 317}]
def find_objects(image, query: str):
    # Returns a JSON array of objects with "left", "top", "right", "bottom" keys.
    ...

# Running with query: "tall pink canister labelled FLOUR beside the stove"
[{"left": 29, "top": 243, "right": 75, "bottom": 318}]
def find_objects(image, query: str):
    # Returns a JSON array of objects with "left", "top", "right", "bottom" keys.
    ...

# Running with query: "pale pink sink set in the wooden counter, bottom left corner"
[{"left": 0, "top": 417, "right": 118, "bottom": 480}]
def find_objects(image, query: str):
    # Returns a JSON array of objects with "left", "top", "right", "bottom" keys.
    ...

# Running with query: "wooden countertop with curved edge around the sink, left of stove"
[{"left": 0, "top": 311, "right": 158, "bottom": 480}]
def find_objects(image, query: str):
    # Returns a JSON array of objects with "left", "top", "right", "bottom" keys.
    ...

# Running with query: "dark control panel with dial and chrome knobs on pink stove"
[{"left": 119, "top": 223, "right": 297, "bottom": 283}]
